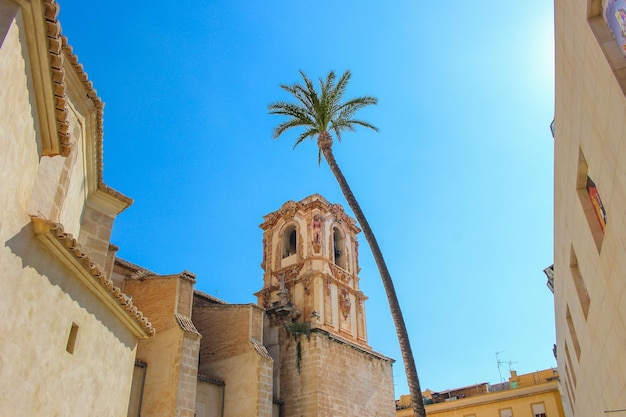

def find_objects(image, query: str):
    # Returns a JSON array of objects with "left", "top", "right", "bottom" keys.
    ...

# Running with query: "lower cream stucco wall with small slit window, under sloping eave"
[{"left": 0, "top": 232, "right": 137, "bottom": 416}]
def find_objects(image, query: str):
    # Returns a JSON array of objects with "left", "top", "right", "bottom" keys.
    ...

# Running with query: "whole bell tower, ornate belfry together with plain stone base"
[{"left": 255, "top": 194, "right": 395, "bottom": 417}]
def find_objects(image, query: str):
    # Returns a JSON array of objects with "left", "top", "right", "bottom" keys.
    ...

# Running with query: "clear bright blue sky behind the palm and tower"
[{"left": 59, "top": 0, "right": 556, "bottom": 397}]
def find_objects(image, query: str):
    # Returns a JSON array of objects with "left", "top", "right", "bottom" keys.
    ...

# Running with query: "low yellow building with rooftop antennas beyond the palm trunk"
[{"left": 396, "top": 369, "right": 565, "bottom": 417}]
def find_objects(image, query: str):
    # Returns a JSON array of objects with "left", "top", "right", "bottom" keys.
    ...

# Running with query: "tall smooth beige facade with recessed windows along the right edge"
[{"left": 554, "top": 0, "right": 626, "bottom": 417}]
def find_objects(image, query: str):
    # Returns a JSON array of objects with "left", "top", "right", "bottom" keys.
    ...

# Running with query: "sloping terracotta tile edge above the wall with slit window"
[{"left": 31, "top": 216, "right": 156, "bottom": 336}]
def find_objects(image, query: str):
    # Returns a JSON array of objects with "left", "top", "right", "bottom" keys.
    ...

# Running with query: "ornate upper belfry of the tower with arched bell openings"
[{"left": 255, "top": 194, "right": 367, "bottom": 347}]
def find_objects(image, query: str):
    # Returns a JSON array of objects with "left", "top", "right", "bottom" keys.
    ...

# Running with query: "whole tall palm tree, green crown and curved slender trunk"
[{"left": 268, "top": 71, "right": 426, "bottom": 417}]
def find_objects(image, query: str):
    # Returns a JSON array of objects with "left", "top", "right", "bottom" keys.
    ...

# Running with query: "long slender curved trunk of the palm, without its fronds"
[{"left": 317, "top": 132, "right": 426, "bottom": 417}]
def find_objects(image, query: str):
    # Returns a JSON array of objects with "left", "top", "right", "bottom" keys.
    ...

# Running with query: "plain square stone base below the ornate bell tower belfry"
[{"left": 280, "top": 330, "right": 395, "bottom": 417}]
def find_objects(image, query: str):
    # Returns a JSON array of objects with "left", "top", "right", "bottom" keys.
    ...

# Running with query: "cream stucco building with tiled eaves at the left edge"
[{"left": 0, "top": 0, "right": 155, "bottom": 417}]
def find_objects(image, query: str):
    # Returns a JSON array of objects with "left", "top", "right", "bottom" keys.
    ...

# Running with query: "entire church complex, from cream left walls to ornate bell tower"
[{"left": 0, "top": 0, "right": 395, "bottom": 417}]
